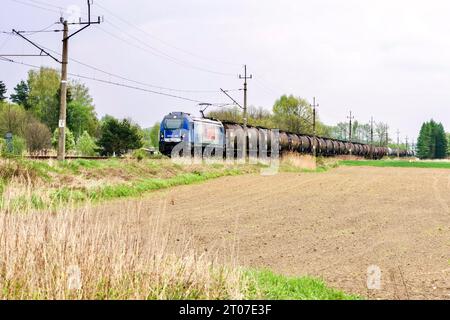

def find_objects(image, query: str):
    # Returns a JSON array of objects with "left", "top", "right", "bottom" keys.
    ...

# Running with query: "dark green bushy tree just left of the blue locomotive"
[{"left": 98, "top": 116, "right": 143, "bottom": 156}]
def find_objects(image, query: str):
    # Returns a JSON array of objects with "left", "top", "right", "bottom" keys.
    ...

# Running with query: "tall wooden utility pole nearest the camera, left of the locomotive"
[{"left": 58, "top": 21, "right": 69, "bottom": 161}]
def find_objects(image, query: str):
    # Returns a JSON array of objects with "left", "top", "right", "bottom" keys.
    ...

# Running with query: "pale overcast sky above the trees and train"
[{"left": 0, "top": 0, "right": 450, "bottom": 138}]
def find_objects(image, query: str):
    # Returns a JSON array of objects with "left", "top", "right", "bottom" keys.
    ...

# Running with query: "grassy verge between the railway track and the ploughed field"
[{"left": 0, "top": 159, "right": 262, "bottom": 211}]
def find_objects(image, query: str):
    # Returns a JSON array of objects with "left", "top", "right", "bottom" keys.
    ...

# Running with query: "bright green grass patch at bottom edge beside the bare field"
[{"left": 246, "top": 270, "right": 361, "bottom": 300}]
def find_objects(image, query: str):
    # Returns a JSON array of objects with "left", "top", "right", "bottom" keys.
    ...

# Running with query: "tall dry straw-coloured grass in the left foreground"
[{"left": 0, "top": 201, "right": 247, "bottom": 299}]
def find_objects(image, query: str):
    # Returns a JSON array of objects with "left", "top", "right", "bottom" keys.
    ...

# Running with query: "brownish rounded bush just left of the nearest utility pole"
[{"left": 24, "top": 119, "right": 52, "bottom": 154}]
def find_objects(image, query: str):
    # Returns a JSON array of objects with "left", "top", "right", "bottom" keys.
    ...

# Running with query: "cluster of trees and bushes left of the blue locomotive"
[{"left": 0, "top": 68, "right": 155, "bottom": 156}]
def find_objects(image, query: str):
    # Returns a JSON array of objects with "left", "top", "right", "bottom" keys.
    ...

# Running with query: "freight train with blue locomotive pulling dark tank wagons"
[{"left": 159, "top": 112, "right": 413, "bottom": 159}]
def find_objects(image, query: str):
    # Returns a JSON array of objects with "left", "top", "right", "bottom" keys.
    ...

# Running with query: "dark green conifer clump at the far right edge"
[{"left": 417, "top": 120, "right": 448, "bottom": 159}]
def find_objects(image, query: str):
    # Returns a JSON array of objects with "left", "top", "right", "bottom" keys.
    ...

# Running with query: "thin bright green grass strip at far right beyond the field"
[{"left": 339, "top": 160, "right": 450, "bottom": 169}]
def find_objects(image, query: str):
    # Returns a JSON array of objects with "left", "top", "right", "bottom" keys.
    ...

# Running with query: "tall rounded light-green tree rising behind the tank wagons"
[{"left": 273, "top": 95, "right": 312, "bottom": 134}]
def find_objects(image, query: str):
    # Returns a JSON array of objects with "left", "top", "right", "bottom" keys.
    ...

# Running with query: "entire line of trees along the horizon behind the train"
[{"left": 0, "top": 68, "right": 450, "bottom": 159}]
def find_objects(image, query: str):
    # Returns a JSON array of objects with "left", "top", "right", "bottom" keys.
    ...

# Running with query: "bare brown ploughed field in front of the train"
[{"left": 102, "top": 167, "right": 450, "bottom": 299}]
